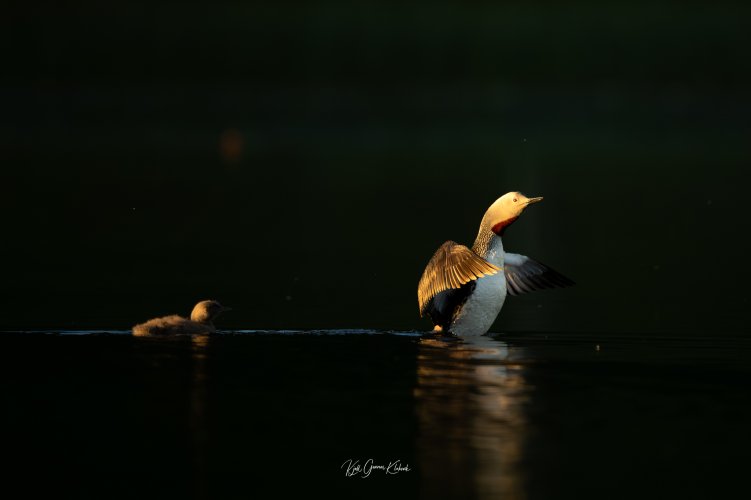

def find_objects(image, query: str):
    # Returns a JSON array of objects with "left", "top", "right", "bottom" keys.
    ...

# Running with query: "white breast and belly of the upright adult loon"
[{"left": 450, "top": 271, "right": 506, "bottom": 337}]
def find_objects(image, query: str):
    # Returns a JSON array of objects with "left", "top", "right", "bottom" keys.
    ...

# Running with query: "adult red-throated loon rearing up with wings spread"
[{"left": 417, "top": 192, "right": 574, "bottom": 336}]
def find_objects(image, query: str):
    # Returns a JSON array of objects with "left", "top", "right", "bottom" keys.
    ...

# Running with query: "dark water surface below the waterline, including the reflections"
[{"left": 0, "top": 330, "right": 751, "bottom": 499}]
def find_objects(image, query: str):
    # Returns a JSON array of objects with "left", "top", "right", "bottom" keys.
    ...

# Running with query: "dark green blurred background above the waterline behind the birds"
[{"left": 0, "top": 2, "right": 751, "bottom": 333}]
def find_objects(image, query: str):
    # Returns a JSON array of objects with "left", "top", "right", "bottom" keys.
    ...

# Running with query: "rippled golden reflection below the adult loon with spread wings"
[{"left": 415, "top": 337, "right": 531, "bottom": 499}]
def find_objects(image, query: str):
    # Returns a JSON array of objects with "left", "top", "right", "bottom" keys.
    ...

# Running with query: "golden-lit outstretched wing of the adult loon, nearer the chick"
[{"left": 417, "top": 241, "right": 500, "bottom": 316}]
